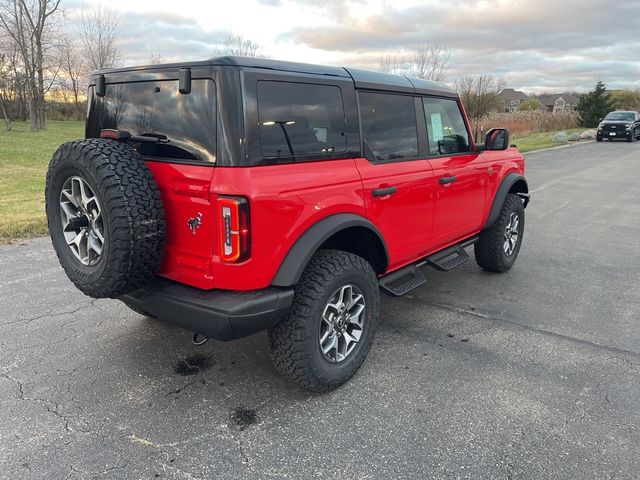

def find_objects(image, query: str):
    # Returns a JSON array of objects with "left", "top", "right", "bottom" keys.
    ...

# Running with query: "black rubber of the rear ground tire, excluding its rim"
[{"left": 269, "top": 250, "right": 380, "bottom": 392}]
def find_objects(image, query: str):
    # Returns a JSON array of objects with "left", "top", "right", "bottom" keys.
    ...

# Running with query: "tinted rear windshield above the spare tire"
[{"left": 87, "top": 80, "right": 216, "bottom": 163}]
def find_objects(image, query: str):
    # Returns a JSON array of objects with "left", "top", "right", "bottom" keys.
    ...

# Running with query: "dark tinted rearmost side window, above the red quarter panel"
[{"left": 258, "top": 81, "right": 347, "bottom": 157}]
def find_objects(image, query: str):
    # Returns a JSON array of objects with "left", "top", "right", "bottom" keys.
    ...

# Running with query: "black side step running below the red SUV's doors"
[{"left": 378, "top": 237, "right": 478, "bottom": 297}]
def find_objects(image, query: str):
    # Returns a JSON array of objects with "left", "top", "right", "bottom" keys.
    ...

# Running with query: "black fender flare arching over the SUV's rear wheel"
[{"left": 271, "top": 213, "right": 389, "bottom": 287}]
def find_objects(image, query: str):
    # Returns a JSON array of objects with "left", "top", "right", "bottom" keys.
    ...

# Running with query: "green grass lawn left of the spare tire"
[{"left": 0, "top": 121, "right": 84, "bottom": 243}]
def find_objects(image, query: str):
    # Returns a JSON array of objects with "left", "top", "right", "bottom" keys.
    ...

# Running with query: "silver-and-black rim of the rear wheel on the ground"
[{"left": 319, "top": 284, "right": 365, "bottom": 363}]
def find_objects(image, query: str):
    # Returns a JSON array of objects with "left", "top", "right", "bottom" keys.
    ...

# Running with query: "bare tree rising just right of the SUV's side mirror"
[{"left": 455, "top": 75, "right": 506, "bottom": 141}]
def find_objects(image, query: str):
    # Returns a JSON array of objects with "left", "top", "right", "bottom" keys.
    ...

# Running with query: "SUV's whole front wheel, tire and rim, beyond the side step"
[{"left": 474, "top": 193, "right": 524, "bottom": 273}]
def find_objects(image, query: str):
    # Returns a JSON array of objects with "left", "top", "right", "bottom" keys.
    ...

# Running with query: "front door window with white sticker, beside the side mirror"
[{"left": 422, "top": 97, "right": 471, "bottom": 155}]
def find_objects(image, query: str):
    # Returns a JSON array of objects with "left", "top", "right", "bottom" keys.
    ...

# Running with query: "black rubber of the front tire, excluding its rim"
[{"left": 474, "top": 193, "right": 525, "bottom": 273}]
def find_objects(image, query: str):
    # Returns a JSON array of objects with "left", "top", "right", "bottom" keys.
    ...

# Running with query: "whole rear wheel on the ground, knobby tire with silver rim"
[{"left": 269, "top": 250, "right": 380, "bottom": 392}]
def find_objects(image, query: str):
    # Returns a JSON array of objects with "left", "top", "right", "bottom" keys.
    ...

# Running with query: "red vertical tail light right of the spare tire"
[{"left": 218, "top": 196, "right": 251, "bottom": 263}]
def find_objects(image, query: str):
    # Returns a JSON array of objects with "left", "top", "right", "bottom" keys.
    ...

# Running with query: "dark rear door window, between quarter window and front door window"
[{"left": 359, "top": 92, "right": 418, "bottom": 161}]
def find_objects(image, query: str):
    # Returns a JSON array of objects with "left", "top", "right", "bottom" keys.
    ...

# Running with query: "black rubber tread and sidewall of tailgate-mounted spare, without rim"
[{"left": 46, "top": 138, "right": 166, "bottom": 298}]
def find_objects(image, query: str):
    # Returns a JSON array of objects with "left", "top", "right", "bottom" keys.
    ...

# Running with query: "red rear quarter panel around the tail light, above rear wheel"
[{"left": 211, "top": 160, "right": 364, "bottom": 290}]
